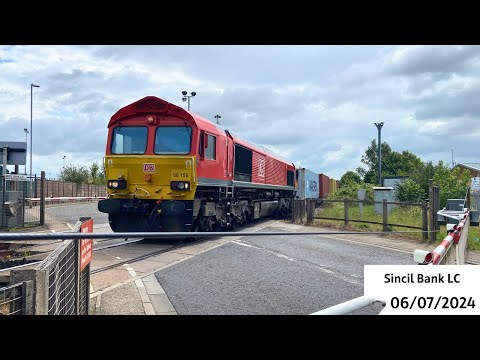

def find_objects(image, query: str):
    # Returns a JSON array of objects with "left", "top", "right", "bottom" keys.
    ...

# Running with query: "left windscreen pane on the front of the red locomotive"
[{"left": 111, "top": 126, "right": 148, "bottom": 154}]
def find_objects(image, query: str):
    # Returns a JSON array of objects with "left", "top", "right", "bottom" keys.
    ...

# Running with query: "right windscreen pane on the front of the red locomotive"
[{"left": 154, "top": 126, "right": 192, "bottom": 154}]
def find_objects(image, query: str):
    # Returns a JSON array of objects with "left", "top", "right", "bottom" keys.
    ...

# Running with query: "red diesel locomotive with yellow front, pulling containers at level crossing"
[{"left": 98, "top": 96, "right": 295, "bottom": 232}]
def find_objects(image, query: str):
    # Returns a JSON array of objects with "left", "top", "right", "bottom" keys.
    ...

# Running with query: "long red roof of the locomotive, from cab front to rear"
[{"left": 108, "top": 96, "right": 294, "bottom": 166}]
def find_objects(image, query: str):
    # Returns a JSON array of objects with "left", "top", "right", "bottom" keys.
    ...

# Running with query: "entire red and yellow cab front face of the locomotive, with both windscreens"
[{"left": 98, "top": 97, "right": 198, "bottom": 232}]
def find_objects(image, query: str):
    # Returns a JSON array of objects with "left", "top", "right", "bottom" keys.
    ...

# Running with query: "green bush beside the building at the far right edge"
[{"left": 433, "top": 161, "right": 471, "bottom": 208}]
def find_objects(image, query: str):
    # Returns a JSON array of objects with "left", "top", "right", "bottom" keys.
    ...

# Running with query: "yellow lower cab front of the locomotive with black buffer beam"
[{"left": 98, "top": 155, "right": 197, "bottom": 232}]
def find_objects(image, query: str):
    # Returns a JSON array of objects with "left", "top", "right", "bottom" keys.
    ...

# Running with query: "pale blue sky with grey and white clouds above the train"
[{"left": 0, "top": 45, "right": 480, "bottom": 179}]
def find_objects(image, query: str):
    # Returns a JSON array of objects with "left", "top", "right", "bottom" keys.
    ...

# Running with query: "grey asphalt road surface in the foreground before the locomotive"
[{"left": 155, "top": 226, "right": 416, "bottom": 315}]
